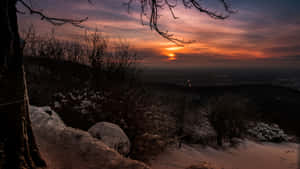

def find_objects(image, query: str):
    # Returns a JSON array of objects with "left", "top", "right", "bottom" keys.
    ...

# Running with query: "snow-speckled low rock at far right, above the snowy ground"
[{"left": 248, "top": 122, "right": 289, "bottom": 142}]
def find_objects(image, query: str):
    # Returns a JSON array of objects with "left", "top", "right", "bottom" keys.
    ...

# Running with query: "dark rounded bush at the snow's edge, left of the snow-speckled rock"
[{"left": 207, "top": 94, "right": 252, "bottom": 146}]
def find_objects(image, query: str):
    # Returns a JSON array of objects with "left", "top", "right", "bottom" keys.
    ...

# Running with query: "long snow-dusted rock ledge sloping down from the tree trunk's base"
[{"left": 30, "top": 106, "right": 150, "bottom": 169}]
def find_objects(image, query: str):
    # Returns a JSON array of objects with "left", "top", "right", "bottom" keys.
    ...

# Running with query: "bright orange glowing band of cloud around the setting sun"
[{"left": 141, "top": 39, "right": 272, "bottom": 63}]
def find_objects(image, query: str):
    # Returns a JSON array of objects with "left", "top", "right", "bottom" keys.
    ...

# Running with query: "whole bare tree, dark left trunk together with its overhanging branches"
[{"left": 0, "top": 0, "right": 233, "bottom": 169}]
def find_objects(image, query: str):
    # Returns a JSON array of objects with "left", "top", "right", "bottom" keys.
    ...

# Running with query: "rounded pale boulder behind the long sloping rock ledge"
[{"left": 88, "top": 122, "right": 130, "bottom": 155}]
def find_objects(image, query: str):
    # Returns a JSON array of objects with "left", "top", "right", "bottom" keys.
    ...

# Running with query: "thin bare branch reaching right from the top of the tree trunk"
[{"left": 18, "top": 0, "right": 91, "bottom": 28}]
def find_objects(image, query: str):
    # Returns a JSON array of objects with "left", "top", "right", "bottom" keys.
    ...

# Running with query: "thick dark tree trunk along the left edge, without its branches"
[{"left": 0, "top": 0, "right": 46, "bottom": 169}]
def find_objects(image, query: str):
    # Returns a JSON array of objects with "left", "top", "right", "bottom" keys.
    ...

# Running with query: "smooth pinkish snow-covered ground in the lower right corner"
[{"left": 151, "top": 140, "right": 299, "bottom": 169}]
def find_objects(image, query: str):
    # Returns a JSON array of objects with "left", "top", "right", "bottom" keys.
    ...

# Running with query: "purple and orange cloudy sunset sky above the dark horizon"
[{"left": 18, "top": 0, "right": 300, "bottom": 68}]
